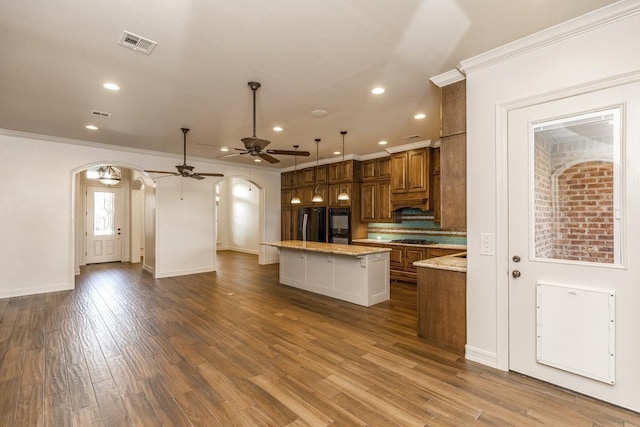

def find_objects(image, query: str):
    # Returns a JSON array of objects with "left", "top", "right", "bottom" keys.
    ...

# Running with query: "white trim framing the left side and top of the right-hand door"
[{"left": 495, "top": 71, "right": 640, "bottom": 371}]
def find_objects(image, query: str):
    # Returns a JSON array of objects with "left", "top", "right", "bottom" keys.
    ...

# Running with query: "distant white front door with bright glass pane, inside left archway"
[{"left": 85, "top": 187, "right": 124, "bottom": 264}]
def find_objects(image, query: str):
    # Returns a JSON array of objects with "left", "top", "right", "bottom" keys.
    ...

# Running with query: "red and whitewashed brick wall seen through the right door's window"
[{"left": 534, "top": 132, "right": 614, "bottom": 263}]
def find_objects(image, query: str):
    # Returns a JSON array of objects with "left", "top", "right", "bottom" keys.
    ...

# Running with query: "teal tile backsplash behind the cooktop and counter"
[{"left": 367, "top": 208, "right": 467, "bottom": 245}]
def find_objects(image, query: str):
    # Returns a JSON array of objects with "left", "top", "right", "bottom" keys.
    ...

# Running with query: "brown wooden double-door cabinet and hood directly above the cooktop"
[{"left": 390, "top": 147, "right": 431, "bottom": 210}]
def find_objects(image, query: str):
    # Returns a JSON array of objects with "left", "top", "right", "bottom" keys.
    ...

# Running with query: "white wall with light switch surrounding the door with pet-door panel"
[{"left": 461, "top": 1, "right": 640, "bottom": 408}]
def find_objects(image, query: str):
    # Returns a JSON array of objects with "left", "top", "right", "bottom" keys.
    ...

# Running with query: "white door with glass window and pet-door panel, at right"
[{"left": 508, "top": 83, "right": 640, "bottom": 410}]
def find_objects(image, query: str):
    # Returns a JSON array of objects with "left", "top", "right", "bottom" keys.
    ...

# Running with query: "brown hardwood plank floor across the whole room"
[{"left": 0, "top": 252, "right": 640, "bottom": 427}]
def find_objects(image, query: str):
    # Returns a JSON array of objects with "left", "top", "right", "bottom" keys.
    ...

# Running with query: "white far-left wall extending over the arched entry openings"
[{"left": 0, "top": 130, "right": 280, "bottom": 298}]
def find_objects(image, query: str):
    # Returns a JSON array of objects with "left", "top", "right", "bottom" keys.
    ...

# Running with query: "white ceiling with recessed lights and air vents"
[{"left": 0, "top": 0, "right": 615, "bottom": 168}]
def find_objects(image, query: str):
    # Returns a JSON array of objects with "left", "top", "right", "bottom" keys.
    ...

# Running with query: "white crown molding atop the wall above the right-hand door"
[{"left": 460, "top": 0, "right": 640, "bottom": 74}]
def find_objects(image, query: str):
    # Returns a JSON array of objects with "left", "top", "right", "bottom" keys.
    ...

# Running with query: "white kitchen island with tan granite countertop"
[{"left": 261, "top": 240, "right": 390, "bottom": 307}]
